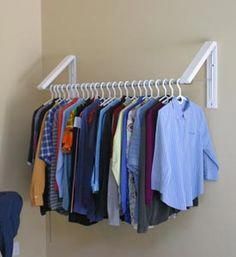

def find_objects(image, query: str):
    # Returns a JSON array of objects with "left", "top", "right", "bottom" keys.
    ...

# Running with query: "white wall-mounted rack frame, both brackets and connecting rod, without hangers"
[{"left": 38, "top": 41, "right": 218, "bottom": 108}]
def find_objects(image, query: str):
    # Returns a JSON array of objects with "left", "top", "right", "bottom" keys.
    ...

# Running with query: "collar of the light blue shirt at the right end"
[{"left": 171, "top": 97, "right": 191, "bottom": 119}]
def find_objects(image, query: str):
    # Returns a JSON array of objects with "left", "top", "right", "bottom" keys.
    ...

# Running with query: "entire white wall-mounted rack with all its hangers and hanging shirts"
[{"left": 27, "top": 41, "right": 219, "bottom": 233}]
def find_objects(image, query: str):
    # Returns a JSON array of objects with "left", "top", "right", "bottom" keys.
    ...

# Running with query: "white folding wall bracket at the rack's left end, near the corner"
[{"left": 38, "top": 55, "right": 77, "bottom": 89}]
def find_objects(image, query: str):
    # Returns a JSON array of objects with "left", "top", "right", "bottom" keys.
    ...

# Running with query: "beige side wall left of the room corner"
[{"left": 0, "top": 0, "right": 46, "bottom": 257}]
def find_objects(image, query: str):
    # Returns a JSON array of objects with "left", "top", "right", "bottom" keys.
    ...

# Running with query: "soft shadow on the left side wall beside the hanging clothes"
[{"left": 0, "top": 60, "right": 46, "bottom": 199}]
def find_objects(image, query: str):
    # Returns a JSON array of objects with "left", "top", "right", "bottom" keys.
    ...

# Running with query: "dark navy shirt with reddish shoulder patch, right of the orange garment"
[{"left": 74, "top": 99, "right": 100, "bottom": 221}]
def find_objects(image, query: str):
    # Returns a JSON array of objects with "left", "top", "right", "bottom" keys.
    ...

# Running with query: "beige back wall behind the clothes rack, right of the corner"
[{"left": 42, "top": 0, "right": 236, "bottom": 257}]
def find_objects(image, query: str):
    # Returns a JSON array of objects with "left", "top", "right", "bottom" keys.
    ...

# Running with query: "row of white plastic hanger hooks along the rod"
[{"left": 47, "top": 79, "right": 186, "bottom": 103}]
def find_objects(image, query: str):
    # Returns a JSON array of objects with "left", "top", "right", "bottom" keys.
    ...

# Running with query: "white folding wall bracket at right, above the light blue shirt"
[{"left": 181, "top": 41, "right": 218, "bottom": 108}]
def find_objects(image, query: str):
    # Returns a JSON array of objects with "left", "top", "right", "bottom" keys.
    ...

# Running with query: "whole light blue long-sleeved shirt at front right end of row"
[{"left": 152, "top": 98, "right": 219, "bottom": 210}]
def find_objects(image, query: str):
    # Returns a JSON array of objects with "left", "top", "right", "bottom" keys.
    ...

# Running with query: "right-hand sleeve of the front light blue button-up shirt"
[{"left": 201, "top": 111, "right": 219, "bottom": 180}]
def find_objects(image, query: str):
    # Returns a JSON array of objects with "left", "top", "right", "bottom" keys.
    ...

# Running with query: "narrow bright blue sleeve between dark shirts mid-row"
[{"left": 91, "top": 99, "right": 121, "bottom": 193}]
